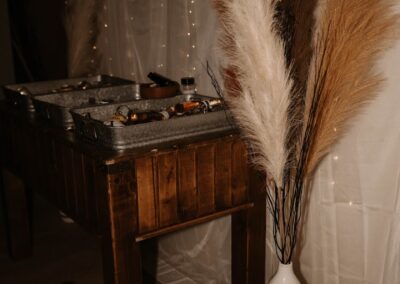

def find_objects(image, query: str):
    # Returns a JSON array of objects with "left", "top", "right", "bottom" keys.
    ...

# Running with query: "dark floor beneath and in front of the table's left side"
[{"left": 0, "top": 194, "right": 103, "bottom": 284}]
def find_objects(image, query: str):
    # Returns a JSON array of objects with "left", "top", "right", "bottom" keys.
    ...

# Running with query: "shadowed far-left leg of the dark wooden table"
[{"left": 2, "top": 168, "right": 32, "bottom": 259}]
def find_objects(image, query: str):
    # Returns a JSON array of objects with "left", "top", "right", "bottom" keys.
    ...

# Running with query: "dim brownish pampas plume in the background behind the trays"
[{"left": 65, "top": 0, "right": 99, "bottom": 77}]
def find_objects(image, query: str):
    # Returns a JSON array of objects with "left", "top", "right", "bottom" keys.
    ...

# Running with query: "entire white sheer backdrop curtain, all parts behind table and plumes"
[{"left": 90, "top": 0, "right": 400, "bottom": 284}]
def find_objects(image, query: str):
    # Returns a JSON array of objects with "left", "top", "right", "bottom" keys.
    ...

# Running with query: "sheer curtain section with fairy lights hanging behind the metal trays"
[{"left": 96, "top": 0, "right": 222, "bottom": 95}]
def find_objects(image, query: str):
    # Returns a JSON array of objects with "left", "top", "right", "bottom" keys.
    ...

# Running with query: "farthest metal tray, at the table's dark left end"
[{"left": 3, "top": 75, "right": 133, "bottom": 111}]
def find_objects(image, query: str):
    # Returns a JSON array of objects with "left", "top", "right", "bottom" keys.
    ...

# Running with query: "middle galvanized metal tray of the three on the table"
[{"left": 32, "top": 85, "right": 139, "bottom": 130}]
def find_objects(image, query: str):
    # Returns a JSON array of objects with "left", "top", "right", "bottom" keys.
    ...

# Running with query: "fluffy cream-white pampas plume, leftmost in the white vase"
[{"left": 216, "top": 0, "right": 292, "bottom": 187}]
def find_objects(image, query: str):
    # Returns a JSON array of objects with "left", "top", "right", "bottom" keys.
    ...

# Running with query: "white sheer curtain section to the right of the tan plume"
[{"left": 300, "top": 38, "right": 400, "bottom": 284}]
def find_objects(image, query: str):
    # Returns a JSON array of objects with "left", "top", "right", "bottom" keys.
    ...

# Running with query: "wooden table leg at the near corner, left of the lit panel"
[{"left": 102, "top": 163, "right": 142, "bottom": 284}]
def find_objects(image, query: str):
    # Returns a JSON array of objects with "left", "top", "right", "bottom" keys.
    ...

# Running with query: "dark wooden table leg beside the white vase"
[{"left": 232, "top": 172, "right": 266, "bottom": 284}]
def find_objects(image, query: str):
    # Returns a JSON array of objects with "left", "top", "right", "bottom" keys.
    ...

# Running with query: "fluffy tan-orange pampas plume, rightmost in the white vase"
[{"left": 305, "top": 0, "right": 398, "bottom": 175}]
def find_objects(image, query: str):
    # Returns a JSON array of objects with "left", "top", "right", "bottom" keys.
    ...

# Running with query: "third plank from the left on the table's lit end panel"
[{"left": 178, "top": 149, "right": 197, "bottom": 220}]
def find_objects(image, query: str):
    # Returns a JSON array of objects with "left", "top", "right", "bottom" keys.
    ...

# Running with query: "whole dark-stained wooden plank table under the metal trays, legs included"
[{"left": 0, "top": 102, "right": 266, "bottom": 284}]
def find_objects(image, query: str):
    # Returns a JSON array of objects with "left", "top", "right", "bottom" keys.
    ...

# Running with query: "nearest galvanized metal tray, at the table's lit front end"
[{"left": 71, "top": 95, "right": 237, "bottom": 150}]
